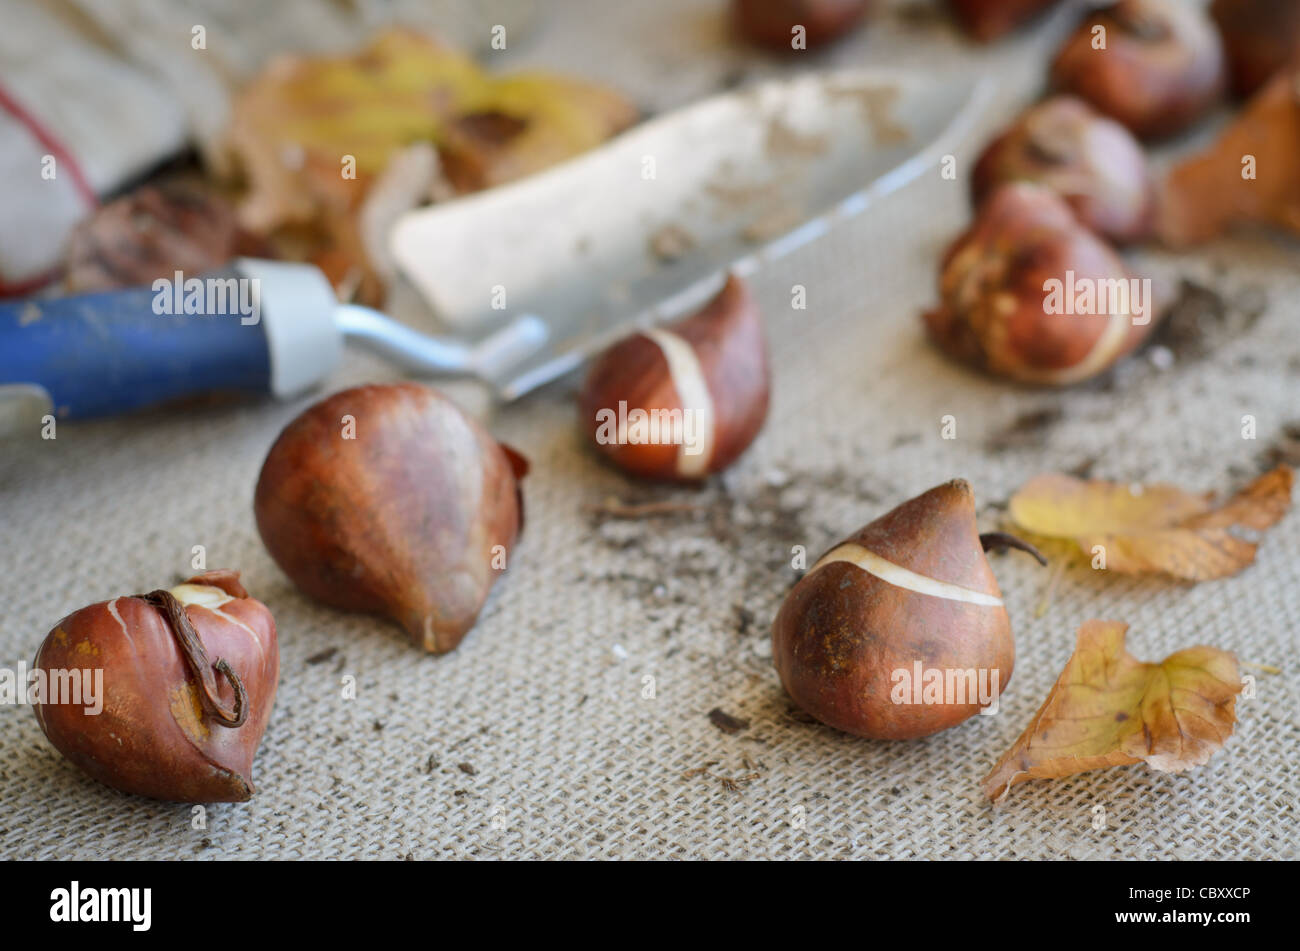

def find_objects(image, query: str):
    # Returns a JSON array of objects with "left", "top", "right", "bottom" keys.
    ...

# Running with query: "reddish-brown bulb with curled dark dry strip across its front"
[{"left": 34, "top": 572, "right": 280, "bottom": 803}]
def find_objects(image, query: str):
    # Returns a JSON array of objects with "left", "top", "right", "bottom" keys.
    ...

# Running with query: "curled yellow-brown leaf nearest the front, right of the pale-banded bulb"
[{"left": 984, "top": 621, "right": 1242, "bottom": 800}]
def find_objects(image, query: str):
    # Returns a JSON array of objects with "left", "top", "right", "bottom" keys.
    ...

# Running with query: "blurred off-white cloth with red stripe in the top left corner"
[{"left": 0, "top": 0, "right": 533, "bottom": 294}]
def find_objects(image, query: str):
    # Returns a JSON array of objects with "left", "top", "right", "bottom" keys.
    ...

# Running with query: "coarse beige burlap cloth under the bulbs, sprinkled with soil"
[{"left": 0, "top": 3, "right": 1300, "bottom": 859}]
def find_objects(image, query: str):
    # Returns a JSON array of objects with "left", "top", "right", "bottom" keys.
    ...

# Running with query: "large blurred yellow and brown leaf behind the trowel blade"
[{"left": 225, "top": 30, "right": 637, "bottom": 304}]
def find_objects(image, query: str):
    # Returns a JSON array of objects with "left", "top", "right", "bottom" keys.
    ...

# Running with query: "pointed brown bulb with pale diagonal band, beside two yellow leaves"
[{"left": 772, "top": 479, "right": 1015, "bottom": 739}]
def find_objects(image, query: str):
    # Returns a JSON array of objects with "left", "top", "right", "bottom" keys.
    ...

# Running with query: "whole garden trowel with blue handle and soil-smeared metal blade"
[{"left": 0, "top": 69, "right": 992, "bottom": 434}]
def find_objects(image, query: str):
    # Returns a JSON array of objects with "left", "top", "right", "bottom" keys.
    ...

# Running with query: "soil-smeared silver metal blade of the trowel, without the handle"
[{"left": 391, "top": 69, "right": 993, "bottom": 400}]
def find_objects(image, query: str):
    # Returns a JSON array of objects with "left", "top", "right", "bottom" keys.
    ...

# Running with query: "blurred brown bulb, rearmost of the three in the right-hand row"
[{"left": 1052, "top": 0, "right": 1226, "bottom": 139}]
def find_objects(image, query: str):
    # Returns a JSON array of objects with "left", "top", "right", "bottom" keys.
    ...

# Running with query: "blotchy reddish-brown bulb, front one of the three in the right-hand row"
[{"left": 924, "top": 182, "right": 1158, "bottom": 386}]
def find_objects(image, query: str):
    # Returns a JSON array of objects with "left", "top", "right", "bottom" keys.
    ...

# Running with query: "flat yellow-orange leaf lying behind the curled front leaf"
[{"left": 1009, "top": 465, "right": 1295, "bottom": 581}]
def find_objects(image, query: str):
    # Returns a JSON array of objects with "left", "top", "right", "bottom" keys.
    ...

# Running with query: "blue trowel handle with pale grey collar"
[{"left": 0, "top": 261, "right": 341, "bottom": 418}]
